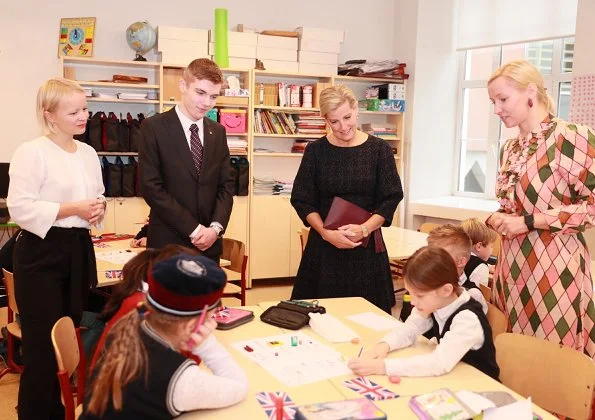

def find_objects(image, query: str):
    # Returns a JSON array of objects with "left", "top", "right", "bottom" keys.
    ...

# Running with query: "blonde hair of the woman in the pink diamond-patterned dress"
[{"left": 488, "top": 60, "right": 556, "bottom": 114}]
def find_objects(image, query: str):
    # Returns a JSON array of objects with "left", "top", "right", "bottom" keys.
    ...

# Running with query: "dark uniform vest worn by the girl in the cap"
[{"left": 79, "top": 325, "right": 195, "bottom": 420}]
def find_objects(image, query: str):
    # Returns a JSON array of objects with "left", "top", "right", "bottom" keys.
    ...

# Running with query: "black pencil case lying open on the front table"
[{"left": 260, "top": 300, "right": 326, "bottom": 330}]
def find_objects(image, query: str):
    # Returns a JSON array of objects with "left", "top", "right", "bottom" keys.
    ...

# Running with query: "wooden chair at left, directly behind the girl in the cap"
[{"left": 52, "top": 316, "right": 87, "bottom": 420}]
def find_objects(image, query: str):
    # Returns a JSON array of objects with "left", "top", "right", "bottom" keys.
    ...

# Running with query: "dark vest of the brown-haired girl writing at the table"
[{"left": 424, "top": 298, "right": 500, "bottom": 380}]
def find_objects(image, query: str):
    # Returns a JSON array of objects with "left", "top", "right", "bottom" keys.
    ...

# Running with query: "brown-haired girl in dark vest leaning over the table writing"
[{"left": 348, "top": 247, "right": 500, "bottom": 380}]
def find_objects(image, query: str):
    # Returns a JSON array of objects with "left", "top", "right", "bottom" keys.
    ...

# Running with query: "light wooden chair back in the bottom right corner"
[{"left": 496, "top": 333, "right": 595, "bottom": 420}]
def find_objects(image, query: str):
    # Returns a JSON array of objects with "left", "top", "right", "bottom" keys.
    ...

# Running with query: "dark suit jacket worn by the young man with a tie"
[{"left": 139, "top": 108, "right": 233, "bottom": 258}]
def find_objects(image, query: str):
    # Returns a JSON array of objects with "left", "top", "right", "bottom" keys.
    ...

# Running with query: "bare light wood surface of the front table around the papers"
[{"left": 180, "top": 298, "right": 556, "bottom": 420}]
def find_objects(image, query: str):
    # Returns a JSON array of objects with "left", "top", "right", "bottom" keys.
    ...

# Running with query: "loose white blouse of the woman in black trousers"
[{"left": 6, "top": 136, "right": 105, "bottom": 239}]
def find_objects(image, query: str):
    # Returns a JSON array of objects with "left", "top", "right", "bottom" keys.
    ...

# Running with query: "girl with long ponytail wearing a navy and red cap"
[{"left": 80, "top": 254, "right": 248, "bottom": 420}]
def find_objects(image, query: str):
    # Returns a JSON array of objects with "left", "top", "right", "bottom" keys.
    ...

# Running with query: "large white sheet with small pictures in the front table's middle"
[{"left": 232, "top": 331, "right": 352, "bottom": 386}]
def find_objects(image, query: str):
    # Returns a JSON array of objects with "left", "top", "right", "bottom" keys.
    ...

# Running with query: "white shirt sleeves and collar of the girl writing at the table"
[{"left": 382, "top": 290, "right": 485, "bottom": 376}]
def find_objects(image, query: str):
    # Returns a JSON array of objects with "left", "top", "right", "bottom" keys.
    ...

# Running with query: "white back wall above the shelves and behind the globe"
[{"left": 0, "top": 0, "right": 395, "bottom": 162}]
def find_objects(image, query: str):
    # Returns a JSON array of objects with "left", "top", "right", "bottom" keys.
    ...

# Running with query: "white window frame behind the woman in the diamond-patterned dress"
[{"left": 453, "top": 36, "right": 574, "bottom": 200}]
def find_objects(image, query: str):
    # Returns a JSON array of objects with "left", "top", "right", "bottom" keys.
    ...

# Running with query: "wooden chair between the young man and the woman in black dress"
[{"left": 221, "top": 238, "right": 248, "bottom": 306}]
